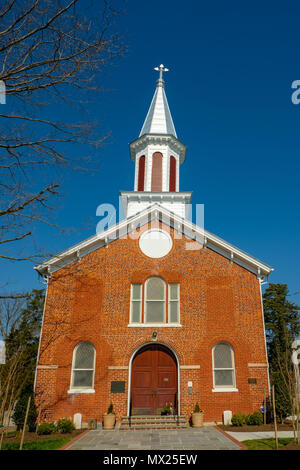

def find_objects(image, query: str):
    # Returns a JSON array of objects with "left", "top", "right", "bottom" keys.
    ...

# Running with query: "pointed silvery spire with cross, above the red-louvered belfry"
[{"left": 139, "top": 64, "right": 177, "bottom": 138}]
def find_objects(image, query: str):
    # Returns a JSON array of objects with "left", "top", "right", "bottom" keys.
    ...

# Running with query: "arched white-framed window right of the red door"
[{"left": 213, "top": 342, "right": 235, "bottom": 388}]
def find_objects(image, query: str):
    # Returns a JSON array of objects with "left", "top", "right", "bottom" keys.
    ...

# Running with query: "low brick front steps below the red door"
[{"left": 120, "top": 415, "right": 188, "bottom": 431}]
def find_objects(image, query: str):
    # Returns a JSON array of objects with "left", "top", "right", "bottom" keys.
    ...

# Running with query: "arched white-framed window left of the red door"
[{"left": 71, "top": 341, "right": 96, "bottom": 389}]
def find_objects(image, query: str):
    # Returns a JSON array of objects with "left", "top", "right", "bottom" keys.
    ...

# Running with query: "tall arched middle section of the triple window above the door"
[{"left": 145, "top": 277, "right": 166, "bottom": 323}]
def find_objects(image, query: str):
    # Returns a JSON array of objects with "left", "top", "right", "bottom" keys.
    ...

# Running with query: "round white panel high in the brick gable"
[{"left": 139, "top": 228, "right": 173, "bottom": 258}]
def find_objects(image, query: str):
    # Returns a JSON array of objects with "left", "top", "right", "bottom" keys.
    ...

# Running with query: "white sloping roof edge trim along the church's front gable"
[{"left": 34, "top": 204, "right": 273, "bottom": 278}]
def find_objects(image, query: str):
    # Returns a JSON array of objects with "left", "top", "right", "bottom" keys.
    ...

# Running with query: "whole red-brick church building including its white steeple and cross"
[{"left": 35, "top": 66, "right": 272, "bottom": 423}]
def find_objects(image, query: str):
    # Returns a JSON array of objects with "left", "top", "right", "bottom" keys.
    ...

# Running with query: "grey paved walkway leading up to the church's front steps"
[{"left": 67, "top": 426, "right": 240, "bottom": 450}]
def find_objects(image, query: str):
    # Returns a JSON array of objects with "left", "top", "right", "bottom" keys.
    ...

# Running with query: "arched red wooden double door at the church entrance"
[{"left": 131, "top": 344, "right": 177, "bottom": 415}]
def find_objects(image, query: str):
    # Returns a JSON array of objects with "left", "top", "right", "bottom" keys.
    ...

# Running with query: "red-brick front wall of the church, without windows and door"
[{"left": 36, "top": 222, "right": 268, "bottom": 422}]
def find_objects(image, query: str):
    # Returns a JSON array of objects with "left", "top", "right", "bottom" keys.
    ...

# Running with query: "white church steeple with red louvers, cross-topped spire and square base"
[{"left": 121, "top": 64, "right": 192, "bottom": 218}]
